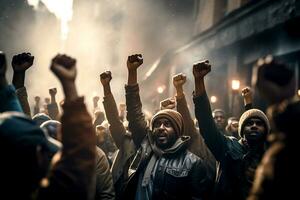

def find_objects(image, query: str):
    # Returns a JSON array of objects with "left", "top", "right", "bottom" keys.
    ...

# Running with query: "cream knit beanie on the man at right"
[{"left": 238, "top": 109, "right": 271, "bottom": 137}]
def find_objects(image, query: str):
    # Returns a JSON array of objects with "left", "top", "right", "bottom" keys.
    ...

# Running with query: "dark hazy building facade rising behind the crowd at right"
[{"left": 142, "top": 0, "right": 300, "bottom": 116}]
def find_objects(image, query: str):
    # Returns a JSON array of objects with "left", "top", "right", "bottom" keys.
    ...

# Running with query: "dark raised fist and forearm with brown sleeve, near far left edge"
[{"left": 11, "top": 53, "right": 34, "bottom": 117}]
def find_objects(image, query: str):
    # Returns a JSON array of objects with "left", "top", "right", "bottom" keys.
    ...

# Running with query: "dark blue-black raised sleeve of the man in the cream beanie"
[{"left": 193, "top": 93, "right": 227, "bottom": 161}]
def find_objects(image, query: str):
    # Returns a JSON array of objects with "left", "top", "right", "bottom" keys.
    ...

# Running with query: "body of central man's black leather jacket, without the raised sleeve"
[{"left": 124, "top": 136, "right": 212, "bottom": 199}]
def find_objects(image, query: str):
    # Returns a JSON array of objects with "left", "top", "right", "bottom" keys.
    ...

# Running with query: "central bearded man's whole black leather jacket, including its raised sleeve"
[{"left": 123, "top": 84, "right": 213, "bottom": 199}]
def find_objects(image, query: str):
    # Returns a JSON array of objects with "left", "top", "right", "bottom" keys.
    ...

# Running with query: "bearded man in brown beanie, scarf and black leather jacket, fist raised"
[{"left": 124, "top": 55, "right": 211, "bottom": 199}]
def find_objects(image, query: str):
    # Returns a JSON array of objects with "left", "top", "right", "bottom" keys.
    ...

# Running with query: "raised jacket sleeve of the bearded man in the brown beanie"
[{"left": 125, "top": 84, "right": 148, "bottom": 147}]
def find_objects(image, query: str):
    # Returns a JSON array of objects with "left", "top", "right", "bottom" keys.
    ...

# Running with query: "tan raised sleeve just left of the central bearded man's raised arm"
[{"left": 103, "top": 94, "right": 126, "bottom": 149}]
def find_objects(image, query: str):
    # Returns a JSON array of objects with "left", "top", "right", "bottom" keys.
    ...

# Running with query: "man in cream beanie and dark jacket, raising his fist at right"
[{"left": 193, "top": 60, "right": 270, "bottom": 200}]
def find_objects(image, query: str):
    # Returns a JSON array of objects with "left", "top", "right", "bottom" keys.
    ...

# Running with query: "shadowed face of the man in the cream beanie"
[{"left": 243, "top": 118, "right": 266, "bottom": 141}]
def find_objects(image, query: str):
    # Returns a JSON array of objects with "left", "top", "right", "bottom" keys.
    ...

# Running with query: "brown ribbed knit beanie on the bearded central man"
[{"left": 150, "top": 109, "right": 184, "bottom": 136}]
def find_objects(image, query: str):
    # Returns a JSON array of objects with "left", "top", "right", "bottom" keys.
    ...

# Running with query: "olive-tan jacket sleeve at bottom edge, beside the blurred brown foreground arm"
[{"left": 96, "top": 147, "right": 115, "bottom": 200}]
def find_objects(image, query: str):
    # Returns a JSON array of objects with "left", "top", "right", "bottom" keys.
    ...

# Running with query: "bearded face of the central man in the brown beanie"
[{"left": 153, "top": 118, "right": 178, "bottom": 149}]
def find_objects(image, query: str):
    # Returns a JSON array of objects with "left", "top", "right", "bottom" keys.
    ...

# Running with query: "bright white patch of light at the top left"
[{"left": 27, "top": 0, "right": 73, "bottom": 41}]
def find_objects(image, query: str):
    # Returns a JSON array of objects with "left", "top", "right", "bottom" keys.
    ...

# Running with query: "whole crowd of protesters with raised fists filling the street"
[{"left": 0, "top": 52, "right": 300, "bottom": 200}]
